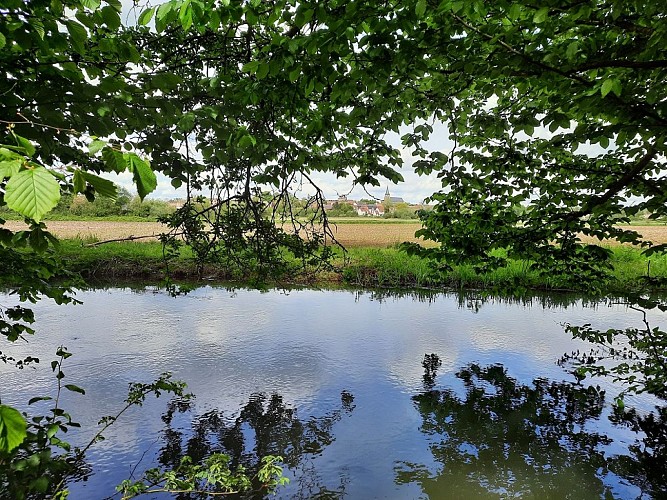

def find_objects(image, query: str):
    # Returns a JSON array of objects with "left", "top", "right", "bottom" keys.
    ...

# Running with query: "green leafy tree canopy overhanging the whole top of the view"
[{"left": 0, "top": 0, "right": 667, "bottom": 277}]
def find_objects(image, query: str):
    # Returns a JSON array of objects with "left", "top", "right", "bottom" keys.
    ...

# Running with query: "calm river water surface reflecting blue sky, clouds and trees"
[{"left": 0, "top": 288, "right": 667, "bottom": 499}]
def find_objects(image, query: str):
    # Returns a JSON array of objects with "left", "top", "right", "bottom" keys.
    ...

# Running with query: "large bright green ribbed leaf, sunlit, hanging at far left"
[{"left": 5, "top": 167, "right": 60, "bottom": 222}]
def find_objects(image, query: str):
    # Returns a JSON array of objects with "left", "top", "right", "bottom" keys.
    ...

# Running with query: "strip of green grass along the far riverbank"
[{"left": 53, "top": 240, "right": 667, "bottom": 293}]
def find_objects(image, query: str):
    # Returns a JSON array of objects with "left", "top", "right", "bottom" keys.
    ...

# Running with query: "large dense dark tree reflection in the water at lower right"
[{"left": 397, "top": 355, "right": 667, "bottom": 498}]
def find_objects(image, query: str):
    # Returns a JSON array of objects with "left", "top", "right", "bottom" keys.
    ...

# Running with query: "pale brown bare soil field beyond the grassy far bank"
[{"left": 5, "top": 221, "right": 667, "bottom": 248}]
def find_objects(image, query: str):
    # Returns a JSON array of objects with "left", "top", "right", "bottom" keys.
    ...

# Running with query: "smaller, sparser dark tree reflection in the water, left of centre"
[{"left": 159, "top": 391, "right": 355, "bottom": 498}]
